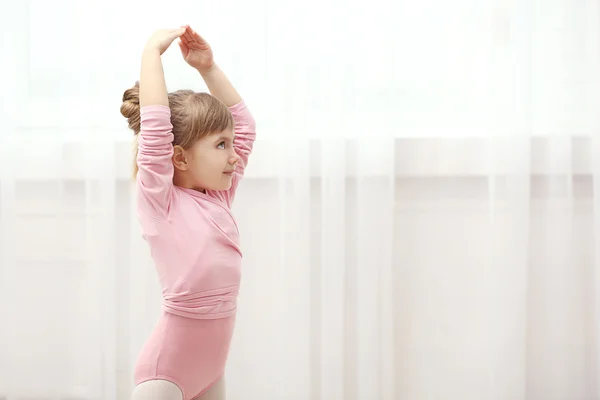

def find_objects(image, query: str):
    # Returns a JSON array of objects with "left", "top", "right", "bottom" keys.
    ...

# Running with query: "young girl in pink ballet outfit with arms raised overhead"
[{"left": 121, "top": 25, "right": 255, "bottom": 400}]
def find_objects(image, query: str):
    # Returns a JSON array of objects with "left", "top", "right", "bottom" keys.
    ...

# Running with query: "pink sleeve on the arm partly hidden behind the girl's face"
[{"left": 211, "top": 101, "right": 256, "bottom": 207}]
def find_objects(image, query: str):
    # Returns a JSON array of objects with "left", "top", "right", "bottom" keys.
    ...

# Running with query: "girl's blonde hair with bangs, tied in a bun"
[{"left": 121, "top": 82, "right": 234, "bottom": 177}]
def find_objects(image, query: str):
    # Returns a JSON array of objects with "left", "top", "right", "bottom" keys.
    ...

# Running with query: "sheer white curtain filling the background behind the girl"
[{"left": 0, "top": 0, "right": 600, "bottom": 400}]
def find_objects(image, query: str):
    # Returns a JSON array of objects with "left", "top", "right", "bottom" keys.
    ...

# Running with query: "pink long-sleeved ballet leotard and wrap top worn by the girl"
[{"left": 134, "top": 102, "right": 256, "bottom": 400}]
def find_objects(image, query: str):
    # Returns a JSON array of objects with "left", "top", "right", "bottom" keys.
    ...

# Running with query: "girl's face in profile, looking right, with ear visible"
[{"left": 173, "top": 129, "right": 240, "bottom": 190}]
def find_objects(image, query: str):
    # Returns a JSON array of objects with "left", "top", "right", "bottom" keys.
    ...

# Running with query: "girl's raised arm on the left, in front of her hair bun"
[{"left": 137, "top": 28, "right": 185, "bottom": 218}]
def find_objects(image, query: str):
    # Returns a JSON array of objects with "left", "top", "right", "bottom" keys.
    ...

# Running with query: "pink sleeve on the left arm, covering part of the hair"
[{"left": 137, "top": 105, "right": 173, "bottom": 218}]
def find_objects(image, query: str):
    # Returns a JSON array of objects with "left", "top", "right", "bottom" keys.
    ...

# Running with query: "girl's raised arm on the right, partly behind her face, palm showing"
[{"left": 179, "top": 25, "right": 256, "bottom": 206}]
